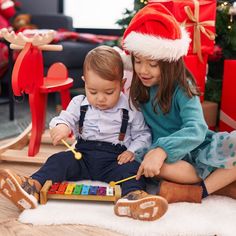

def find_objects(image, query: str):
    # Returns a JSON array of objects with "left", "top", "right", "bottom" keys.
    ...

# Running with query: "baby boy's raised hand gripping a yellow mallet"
[{"left": 50, "top": 124, "right": 71, "bottom": 145}]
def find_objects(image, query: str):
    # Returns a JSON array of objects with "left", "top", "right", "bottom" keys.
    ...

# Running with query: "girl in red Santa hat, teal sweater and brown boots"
[{"left": 122, "top": 3, "right": 236, "bottom": 203}]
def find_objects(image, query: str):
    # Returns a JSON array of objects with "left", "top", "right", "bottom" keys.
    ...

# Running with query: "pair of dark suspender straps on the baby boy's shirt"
[{"left": 79, "top": 105, "right": 129, "bottom": 141}]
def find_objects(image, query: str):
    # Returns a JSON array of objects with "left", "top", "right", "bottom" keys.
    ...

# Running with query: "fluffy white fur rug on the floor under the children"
[{"left": 18, "top": 182, "right": 236, "bottom": 236}]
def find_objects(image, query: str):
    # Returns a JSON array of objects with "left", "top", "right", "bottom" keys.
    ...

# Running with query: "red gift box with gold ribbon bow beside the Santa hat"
[{"left": 172, "top": 0, "right": 216, "bottom": 60}]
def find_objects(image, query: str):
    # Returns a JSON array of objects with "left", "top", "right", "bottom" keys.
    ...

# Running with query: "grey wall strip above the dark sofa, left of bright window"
[{"left": 19, "top": 0, "right": 58, "bottom": 14}]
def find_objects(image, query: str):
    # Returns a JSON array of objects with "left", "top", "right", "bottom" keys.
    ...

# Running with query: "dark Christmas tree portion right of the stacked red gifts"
[{"left": 205, "top": 1, "right": 236, "bottom": 103}]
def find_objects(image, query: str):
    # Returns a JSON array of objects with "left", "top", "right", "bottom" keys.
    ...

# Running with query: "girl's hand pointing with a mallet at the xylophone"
[{"left": 136, "top": 147, "right": 167, "bottom": 180}]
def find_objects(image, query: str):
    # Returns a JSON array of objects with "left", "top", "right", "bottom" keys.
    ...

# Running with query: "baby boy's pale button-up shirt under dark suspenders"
[{"left": 49, "top": 93, "right": 151, "bottom": 153}]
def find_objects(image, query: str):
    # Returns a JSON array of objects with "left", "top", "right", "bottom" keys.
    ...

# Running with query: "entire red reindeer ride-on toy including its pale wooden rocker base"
[{"left": 0, "top": 29, "right": 73, "bottom": 163}]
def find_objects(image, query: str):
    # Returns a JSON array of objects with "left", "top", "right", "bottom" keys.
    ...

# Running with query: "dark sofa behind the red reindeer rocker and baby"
[{"left": 31, "top": 14, "right": 98, "bottom": 88}]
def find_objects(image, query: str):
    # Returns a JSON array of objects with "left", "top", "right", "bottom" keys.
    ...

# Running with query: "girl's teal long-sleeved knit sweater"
[{"left": 141, "top": 86, "right": 213, "bottom": 163}]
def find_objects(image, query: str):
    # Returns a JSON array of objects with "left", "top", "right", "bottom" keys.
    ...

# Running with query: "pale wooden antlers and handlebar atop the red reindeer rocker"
[{"left": 0, "top": 28, "right": 62, "bottom": 51}]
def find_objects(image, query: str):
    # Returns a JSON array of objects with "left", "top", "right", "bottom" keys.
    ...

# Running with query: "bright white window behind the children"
[{"left": 62, "top": 0, "right": 134, "bottom": 32}]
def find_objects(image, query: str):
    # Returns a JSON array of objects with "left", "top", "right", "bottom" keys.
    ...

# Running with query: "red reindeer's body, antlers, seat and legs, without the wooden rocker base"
[{"left": 0, "top": 29, "right": 73, "bottom": 156}]
